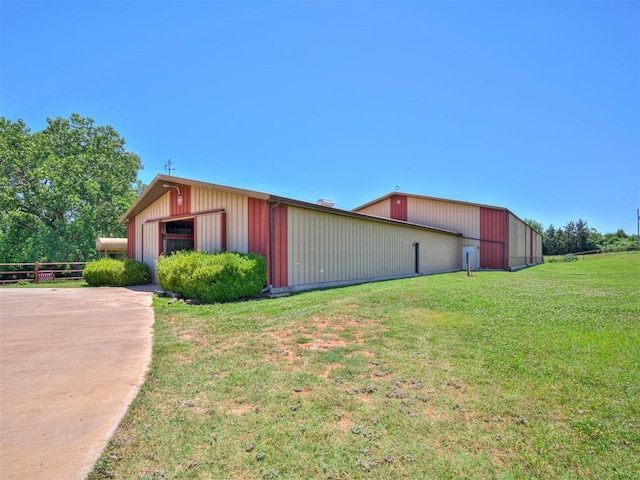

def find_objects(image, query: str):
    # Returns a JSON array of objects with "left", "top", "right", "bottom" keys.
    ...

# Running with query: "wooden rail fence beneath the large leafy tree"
[{"left": 0, "top": 262, "right": 87, "bottom": 284}]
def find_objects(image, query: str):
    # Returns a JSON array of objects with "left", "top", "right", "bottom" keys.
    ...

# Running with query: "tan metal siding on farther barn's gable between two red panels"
[{"left": 407, "top": 197, "right": 480, "bottom": 238}]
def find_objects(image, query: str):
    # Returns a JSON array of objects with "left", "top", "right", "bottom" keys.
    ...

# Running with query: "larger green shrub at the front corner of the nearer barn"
[{"left": 156, "top": 251, "right": 267, "bottom": 303}]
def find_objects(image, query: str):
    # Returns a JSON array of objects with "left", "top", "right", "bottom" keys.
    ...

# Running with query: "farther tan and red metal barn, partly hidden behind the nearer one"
[{"left": 353, "top": 192, "right": 543, "bottom": 269}]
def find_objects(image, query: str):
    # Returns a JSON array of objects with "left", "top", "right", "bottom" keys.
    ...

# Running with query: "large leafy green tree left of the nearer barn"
[{"left": 0, "top": 114, "right": 142, "bottom": 262}]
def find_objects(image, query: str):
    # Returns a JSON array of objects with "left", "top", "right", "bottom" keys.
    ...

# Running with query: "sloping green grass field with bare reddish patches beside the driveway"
[{"left": 89, "top": 252, "right": 640, "bottom": 480}]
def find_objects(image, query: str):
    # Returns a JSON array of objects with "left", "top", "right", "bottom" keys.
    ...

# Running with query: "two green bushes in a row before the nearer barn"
[{"left": 83, "top": 251, "right": 267, "bottom": 303}]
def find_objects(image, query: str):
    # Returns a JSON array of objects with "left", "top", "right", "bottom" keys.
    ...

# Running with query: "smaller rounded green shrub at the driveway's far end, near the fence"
[{"left": 82, "top": 258, "right": 151, "bottom": 287}]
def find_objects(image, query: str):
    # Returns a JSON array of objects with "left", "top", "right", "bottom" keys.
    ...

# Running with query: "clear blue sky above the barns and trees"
[{"left": 0, "top": 0, "right": 640, "bottom": 233}]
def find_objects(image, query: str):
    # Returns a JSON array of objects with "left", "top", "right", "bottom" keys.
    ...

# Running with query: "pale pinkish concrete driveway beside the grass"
[{"left": 0, "top": 288, "right": 153, "bottom": 480}]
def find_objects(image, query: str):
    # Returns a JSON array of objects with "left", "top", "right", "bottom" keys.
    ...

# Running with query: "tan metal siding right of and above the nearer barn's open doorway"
[{"left": 191, "top": 187, "right": 249, "bottom": 253}]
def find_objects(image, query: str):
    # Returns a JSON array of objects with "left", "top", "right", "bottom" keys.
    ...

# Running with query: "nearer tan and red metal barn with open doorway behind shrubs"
[{"left": 120, "top": 175, "right": 469, "bottom": 293}]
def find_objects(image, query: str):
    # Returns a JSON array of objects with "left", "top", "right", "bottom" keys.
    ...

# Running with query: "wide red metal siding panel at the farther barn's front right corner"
[{"left": 480, "top": 207, "right": 509, "bottom": 269}]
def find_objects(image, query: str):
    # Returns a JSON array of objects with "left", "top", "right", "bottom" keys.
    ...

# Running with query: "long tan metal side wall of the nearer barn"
[{"left": 287, "top": 206, "right": 461, "bottom": 286}]
